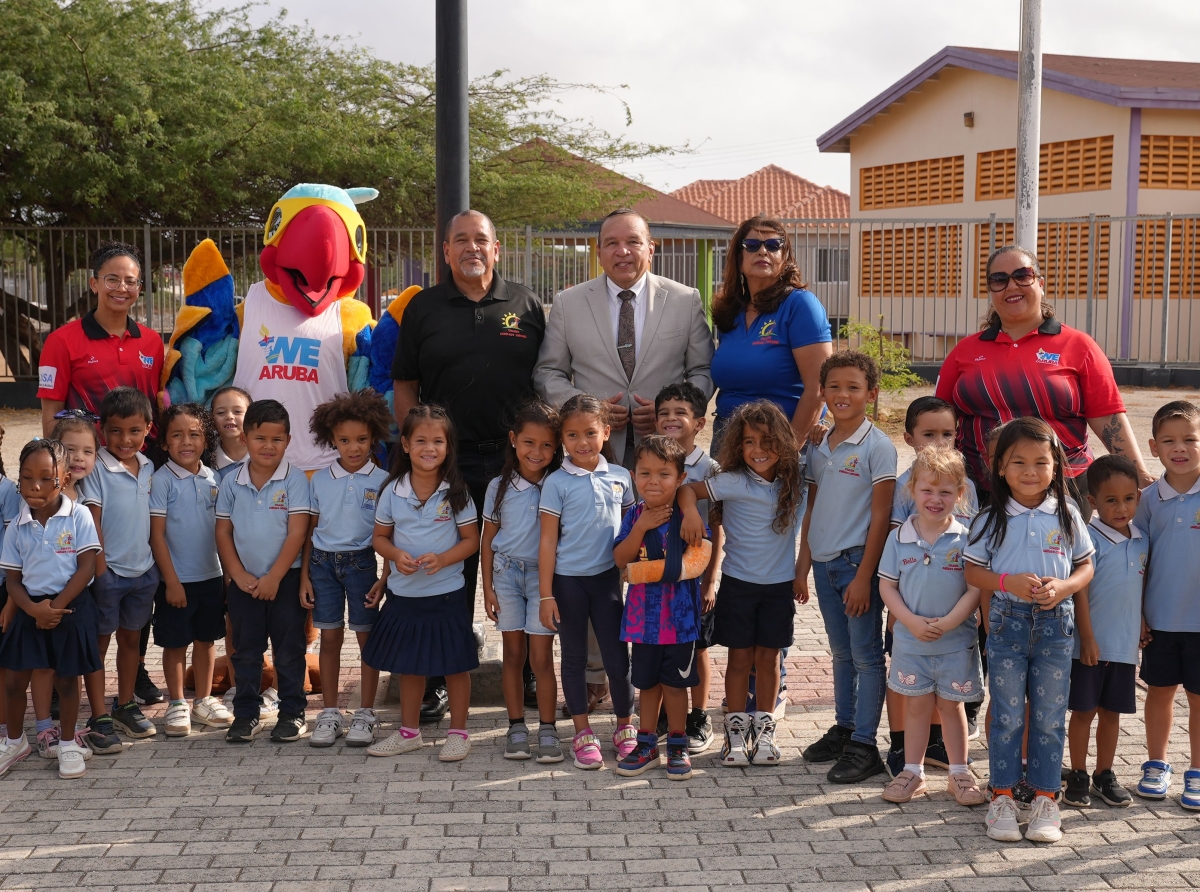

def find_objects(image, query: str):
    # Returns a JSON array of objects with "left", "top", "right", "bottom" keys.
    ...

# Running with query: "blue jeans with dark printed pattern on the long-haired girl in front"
[{"left": 988, "top": 597, "right": 1075, "bottom": 792}]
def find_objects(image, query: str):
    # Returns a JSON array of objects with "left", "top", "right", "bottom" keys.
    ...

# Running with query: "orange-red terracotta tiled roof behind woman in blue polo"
[{"left": 671, "top": 164, "right": 850, "bottom": 223}]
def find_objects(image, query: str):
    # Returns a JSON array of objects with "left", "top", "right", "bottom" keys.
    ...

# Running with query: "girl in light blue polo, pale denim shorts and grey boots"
[{"left": 480, "top": 401, "right": 563, "bottom": 762}]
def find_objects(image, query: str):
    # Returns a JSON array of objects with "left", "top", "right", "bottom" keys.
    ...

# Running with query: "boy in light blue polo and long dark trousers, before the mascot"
[{"left": 216, "top": 400, "right": 311, "bottom": 743}]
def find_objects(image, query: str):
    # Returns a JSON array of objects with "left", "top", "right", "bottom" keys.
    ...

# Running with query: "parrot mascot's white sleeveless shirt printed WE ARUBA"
[{"left": 233, "top": 282, "right": 349, "bottom": 471}]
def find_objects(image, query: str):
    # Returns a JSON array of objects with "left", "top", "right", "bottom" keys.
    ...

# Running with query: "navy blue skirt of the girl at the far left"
[{"left": 0, "top": 589, "right": 103, "bottom": 678}]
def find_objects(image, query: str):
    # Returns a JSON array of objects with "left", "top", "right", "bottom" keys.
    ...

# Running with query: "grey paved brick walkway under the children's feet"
[{"left": 0, "top": 585, "right": 1200, "bottom": 892}]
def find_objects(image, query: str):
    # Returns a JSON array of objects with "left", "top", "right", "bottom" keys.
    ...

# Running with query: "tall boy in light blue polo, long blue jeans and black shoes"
[{"left": 797, "top": 351, "right": 896, "bottom": 784}]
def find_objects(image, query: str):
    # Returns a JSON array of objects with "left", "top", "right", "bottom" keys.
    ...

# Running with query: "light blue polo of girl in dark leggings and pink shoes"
[{"left": 539, "top": 456, "right": 634, "bottom": 576}]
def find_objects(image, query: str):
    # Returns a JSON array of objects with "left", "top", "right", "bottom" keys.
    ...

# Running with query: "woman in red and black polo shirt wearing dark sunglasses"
[{"left": 937, "top": 245, "right": 1154, "bottom": 505}]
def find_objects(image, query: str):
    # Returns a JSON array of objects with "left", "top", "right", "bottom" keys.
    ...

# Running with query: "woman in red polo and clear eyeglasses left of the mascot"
[{"left": 37, "top": 241, "right": 163, "bottom": 437}]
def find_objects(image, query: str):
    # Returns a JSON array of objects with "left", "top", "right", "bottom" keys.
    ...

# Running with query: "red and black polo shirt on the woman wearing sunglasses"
[{"left": 937, "top": 318, "right": 1124, "bottom": 483}]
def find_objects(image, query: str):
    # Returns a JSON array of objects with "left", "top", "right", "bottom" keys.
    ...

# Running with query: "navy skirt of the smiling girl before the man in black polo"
[{"left": 362, "top": 588, "right": 479, "bottom": 676}]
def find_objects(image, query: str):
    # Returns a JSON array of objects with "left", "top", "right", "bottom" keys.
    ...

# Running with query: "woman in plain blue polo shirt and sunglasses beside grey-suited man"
[{"left": 712, "top": 216, "right": 833, "bottom": 454}]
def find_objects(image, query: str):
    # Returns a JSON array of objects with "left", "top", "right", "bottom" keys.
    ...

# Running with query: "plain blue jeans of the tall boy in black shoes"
[{"left": 812, "top": 546, "right": 887, "bottom": 746}]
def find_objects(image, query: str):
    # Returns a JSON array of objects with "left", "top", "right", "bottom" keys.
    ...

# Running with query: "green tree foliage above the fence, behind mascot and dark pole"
[{"left": 0, "top": 0, "right": 671, "bottom": 226}]
